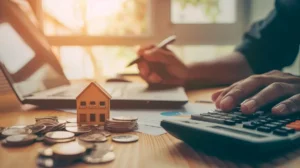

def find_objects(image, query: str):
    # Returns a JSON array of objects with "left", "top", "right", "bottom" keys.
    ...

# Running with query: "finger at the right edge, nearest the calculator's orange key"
[{"left": 272, "top": 94, "right": 300, "bottom": 115}]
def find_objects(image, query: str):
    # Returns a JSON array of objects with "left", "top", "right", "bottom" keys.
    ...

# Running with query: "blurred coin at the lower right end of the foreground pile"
[{"left": 83, "top": 152, "right": 116, "bottom": 164}]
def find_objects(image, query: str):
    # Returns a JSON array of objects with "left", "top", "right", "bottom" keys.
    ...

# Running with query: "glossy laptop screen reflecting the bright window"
[{"left": 0, "top": 22, "right": 68, "bottom": 99}]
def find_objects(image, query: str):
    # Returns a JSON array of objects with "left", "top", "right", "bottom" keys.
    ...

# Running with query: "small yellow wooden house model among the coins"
[{"left": 76, "top": 82, "right": 111, "bottom": 125}]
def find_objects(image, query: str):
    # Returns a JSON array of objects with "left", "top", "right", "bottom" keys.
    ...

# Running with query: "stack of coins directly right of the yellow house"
[{"left": 104, "top": 116, "right": 138, "bottom": 133}]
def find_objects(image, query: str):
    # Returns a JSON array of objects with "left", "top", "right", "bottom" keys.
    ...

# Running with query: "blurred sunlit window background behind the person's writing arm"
[{"left": 0, "top": 0, "right": 300, "bottom": 92}]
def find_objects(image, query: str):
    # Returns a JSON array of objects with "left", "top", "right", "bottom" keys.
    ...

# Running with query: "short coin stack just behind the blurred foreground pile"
[{"left": 44, "top": 131, "right": 75, "bottom": 144}]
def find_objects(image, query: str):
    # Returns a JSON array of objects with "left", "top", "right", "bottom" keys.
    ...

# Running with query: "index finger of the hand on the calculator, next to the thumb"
[{"left": 219, "top": 76, "right": 267, "bottom": 111}]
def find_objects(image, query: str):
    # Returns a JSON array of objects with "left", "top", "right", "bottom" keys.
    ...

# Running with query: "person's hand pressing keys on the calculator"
[{"left": 212, "top": 71, "right": 300, "bottom": 115}]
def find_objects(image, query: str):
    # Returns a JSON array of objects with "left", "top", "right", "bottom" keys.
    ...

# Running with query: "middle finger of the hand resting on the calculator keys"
[{"left": 241, "top": 82, "right": 298, "bottom": 114}]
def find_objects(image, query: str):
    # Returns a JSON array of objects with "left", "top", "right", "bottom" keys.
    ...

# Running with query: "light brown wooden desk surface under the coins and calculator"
[{"left": 0, "top": 89, "right": 300, "bottom": 168}]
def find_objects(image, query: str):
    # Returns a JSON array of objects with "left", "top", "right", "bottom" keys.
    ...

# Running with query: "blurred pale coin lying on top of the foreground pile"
[{"left": 52, "top": 142, "right": 86, "bottom": 156}]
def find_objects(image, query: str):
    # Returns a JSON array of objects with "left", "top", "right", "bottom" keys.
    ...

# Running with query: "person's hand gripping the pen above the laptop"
[{"left": 137, "top": 45, "right": 188, "bottom": 85}]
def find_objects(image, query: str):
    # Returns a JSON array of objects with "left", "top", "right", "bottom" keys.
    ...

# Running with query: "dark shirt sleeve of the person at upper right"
[{"left": 236, "top": 0, "right": 300, "bottom": 74}]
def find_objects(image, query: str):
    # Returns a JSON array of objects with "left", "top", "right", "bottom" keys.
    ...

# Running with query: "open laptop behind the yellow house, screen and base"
[{"left": 0, "top": 1, "right": 188, "bottom": 108}]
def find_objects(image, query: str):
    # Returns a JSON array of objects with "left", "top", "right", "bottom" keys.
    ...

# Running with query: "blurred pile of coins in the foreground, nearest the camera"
[{"left": 37, "top": 142, "right": 115, "bottom": 167}]
